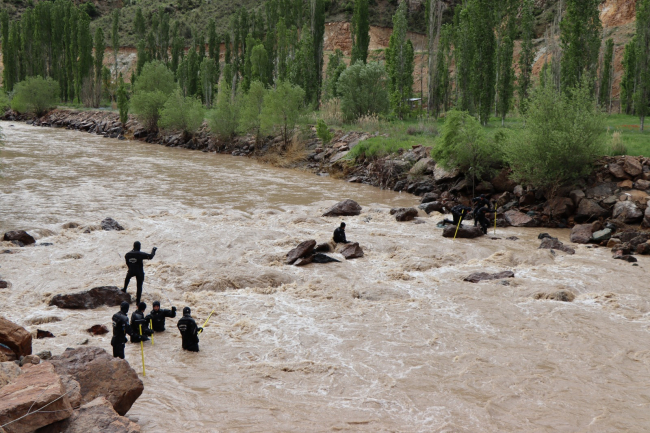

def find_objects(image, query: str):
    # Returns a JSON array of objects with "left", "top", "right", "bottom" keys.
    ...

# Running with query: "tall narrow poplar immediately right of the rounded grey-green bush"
[{"left": 386, "top": 2, "right": 414, "bottom": 119}]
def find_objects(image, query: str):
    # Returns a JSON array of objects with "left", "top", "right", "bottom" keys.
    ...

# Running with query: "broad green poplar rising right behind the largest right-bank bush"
[{"left": 560, "top": 0, "right": 602, "bottom": 90}]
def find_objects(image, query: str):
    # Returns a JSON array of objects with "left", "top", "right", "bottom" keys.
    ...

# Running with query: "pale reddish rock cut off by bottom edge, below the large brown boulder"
[{"left": 39, "top": 397, "right": 141, "bottom": 433}]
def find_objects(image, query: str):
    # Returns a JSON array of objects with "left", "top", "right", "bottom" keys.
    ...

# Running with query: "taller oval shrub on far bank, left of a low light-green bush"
[{"left": 131, "top": 61, "right": 176, "bottom": 131}]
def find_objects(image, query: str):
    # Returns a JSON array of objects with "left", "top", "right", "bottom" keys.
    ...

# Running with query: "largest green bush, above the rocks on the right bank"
[{"left": 505, "top": 77, "right": 606, "bottom": 195}]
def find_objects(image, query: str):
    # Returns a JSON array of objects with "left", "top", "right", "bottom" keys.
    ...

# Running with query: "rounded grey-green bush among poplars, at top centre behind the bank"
[{"left": 337, "top": 60, "right": 389, "bottom": 121}]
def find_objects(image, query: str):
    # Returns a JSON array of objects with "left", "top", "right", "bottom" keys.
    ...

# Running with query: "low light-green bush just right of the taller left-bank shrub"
[{"left": 158, "top": 89, "right": 205, "bottom": 138}]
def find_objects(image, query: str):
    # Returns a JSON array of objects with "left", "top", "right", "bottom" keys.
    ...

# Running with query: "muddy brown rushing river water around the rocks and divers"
[{"left": 0, "top": 122, "right": 650, "bottom": 432}]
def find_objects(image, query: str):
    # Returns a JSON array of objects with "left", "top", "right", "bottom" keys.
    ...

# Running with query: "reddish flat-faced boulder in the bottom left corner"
[{"left": 0, "top": 362, "right": 72, "bottom": 433}]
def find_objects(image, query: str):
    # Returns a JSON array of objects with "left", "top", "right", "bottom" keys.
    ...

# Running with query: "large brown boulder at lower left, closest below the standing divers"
[{"left": 49, "top": 346, "right": 144, "bottom": 415}]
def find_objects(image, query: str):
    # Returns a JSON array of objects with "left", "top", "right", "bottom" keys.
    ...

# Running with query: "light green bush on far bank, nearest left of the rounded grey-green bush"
[{"left": 260, "top": 81, "right": 305, "bottom": 148}]
